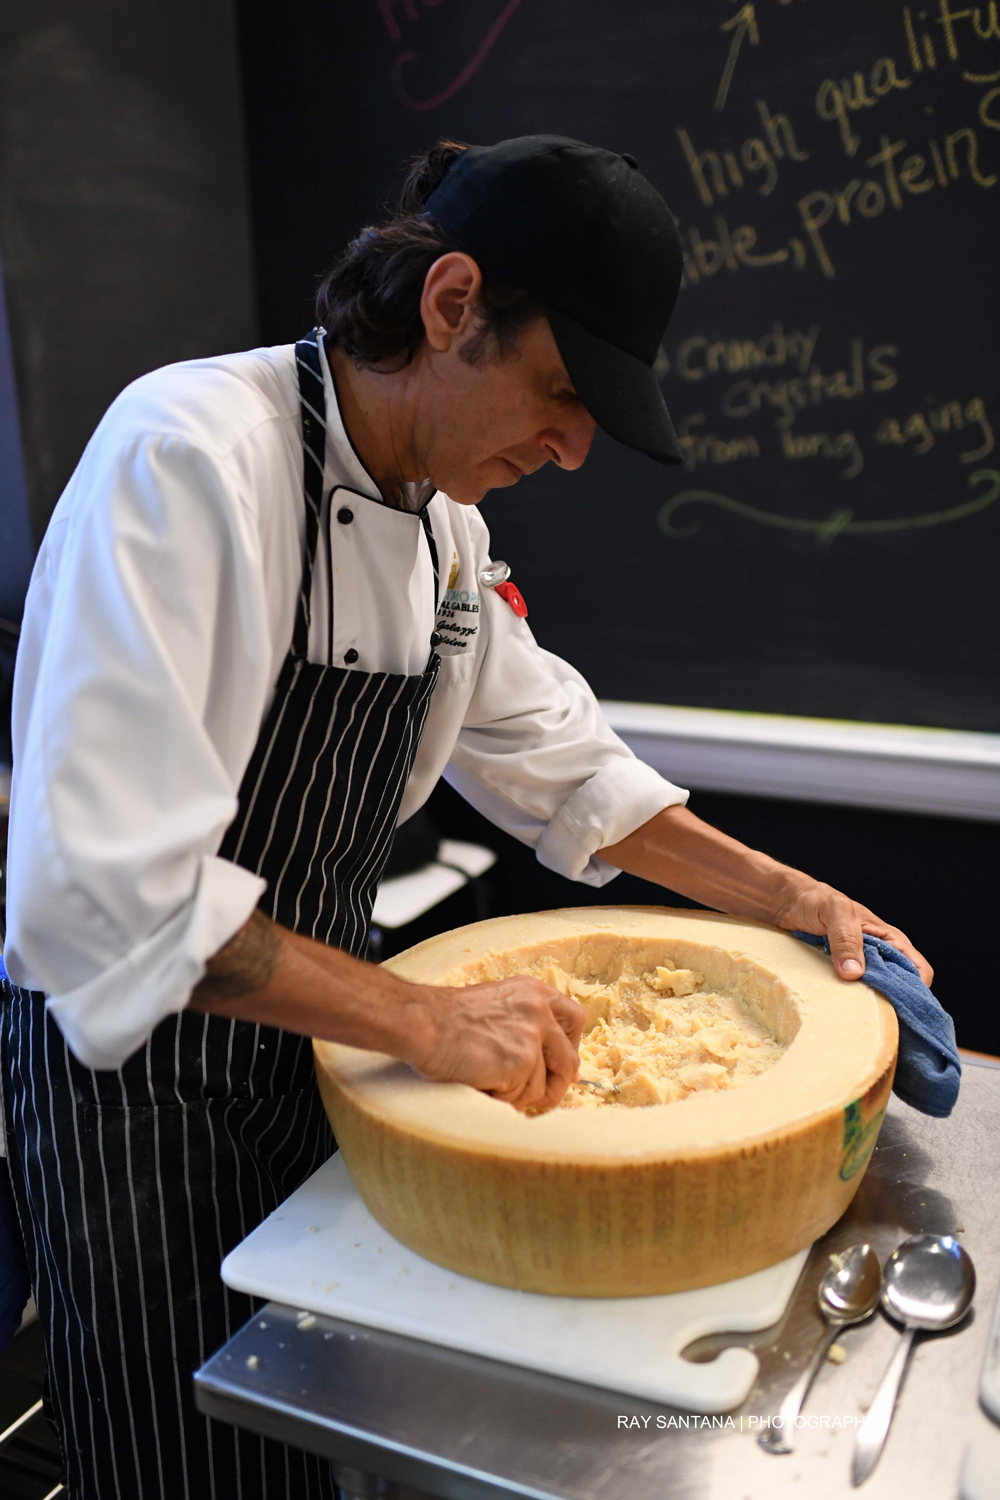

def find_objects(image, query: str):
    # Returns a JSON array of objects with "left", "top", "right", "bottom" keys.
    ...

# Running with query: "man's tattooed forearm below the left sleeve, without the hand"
[{"left": 190, "top": 912, "right": 429, "bottom": 1061}]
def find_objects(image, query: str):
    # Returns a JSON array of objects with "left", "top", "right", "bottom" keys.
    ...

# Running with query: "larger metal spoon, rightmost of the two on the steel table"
[{"left": 850, "top": 1235, "right": 976, "bottom": 1485}]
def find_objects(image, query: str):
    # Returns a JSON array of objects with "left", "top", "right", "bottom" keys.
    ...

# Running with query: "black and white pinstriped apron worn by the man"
[{"left": 3, "top": 335, "right": 439, "bottom": 1500}]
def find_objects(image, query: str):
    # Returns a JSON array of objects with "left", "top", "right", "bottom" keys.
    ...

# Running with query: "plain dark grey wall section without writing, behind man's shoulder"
[{"left": 0, "top": 0, "right": 256, "bottom": 539}]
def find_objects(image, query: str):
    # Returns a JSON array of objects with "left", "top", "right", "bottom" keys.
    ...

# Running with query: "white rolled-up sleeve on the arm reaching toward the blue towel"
[{"left": 445, "top": 531, "right": 688, "bottom": 887}]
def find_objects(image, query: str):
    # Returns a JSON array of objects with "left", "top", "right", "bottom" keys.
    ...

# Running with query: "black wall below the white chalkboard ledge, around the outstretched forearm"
[{"left": 419, "top": 782, "right": 1000, "bottom": 1055}]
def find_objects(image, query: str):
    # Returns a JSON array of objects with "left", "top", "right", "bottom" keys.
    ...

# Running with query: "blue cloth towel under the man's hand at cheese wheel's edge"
[{"left": 795, "top": 933, "right": 963, "bottom": 1119}]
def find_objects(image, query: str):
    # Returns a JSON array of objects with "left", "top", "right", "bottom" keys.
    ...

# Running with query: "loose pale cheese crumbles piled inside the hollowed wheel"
[{"left": 531, "top": 960, "right": 784, "bottom": 1109}]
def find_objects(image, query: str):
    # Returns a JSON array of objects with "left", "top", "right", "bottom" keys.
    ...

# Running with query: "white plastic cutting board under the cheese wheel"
[{"left": 222, "top": 1152, "right": 808, "bottom": 1413}]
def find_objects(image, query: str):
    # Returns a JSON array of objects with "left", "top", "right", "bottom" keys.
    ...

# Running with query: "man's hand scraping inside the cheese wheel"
[{"left": 408, "top": 974, "right": 585, "bottom": 1112}]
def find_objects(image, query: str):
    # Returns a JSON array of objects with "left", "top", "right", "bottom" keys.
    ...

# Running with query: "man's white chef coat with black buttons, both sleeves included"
[{"left": 4, "top": 345, "right": 687, "bottom": 1068}]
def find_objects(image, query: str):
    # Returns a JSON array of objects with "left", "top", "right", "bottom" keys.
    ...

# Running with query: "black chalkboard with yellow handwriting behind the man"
[{"left": 241, "top": 0, "right": 1000, "bottom": 731}]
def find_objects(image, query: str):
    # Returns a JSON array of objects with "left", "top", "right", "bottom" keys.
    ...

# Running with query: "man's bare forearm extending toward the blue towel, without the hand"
[{"left": 598, "top": 807, "right": 808, "bottom": 923}]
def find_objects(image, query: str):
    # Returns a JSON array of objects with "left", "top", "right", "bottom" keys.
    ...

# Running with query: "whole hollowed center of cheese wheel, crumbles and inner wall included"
[{"left": 440, "top": 936, "right": 799, "bottom": 1110}]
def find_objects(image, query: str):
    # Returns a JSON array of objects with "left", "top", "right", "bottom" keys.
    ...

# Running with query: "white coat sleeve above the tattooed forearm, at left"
[{"left": 4, "top": 435, "right": 271, "bottom": 1068}]
